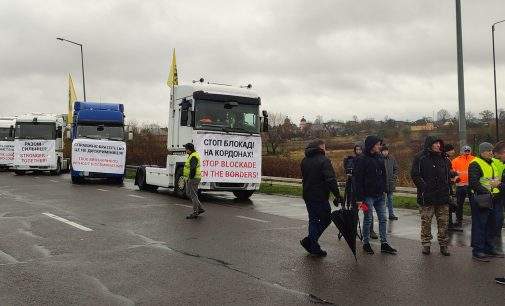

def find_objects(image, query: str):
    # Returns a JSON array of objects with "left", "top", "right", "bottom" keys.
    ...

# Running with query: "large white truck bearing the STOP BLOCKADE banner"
[{"left": 135, "top": 79, "right": 268, "bottom": 199}]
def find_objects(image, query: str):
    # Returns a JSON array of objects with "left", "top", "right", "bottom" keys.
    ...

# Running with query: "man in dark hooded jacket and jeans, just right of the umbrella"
[{"left": 353, "top": 136, "right": 397, "bottom": 254}]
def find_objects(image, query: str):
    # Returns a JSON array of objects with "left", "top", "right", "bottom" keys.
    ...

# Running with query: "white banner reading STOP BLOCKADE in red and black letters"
[{"left": 193, "top": 133, "right": 261, "bottom": 183}]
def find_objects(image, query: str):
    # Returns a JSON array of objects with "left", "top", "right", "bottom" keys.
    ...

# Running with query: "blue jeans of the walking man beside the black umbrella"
[{"left": 305, "top": 202, "right": 331, "bottom": 252}]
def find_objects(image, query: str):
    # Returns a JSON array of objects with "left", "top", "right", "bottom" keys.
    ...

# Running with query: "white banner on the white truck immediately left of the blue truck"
[{"left": 14, "top": 140, "right": 56, "bottom": 166}]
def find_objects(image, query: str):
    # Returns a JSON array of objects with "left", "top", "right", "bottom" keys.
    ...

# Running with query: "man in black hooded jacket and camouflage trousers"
[{"left": 410, "top": 136, "right": 451, "bottom": 256}]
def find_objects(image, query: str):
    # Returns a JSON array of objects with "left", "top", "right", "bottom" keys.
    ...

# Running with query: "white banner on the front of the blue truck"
[{"left": 72, "top": 139, "right": 126, "bottom": 174}]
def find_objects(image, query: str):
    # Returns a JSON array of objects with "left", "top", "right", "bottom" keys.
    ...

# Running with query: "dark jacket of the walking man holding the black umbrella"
[{"left": 301, "top": 145, "right": 341, "bottom": 203}]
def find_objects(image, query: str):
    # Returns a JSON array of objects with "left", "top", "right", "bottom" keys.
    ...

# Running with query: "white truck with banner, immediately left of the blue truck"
[{"left": 13, "top": 114, "right": 69, "bottom": 175}]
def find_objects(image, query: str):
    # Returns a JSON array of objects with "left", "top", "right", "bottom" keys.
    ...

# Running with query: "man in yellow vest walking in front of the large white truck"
[{"left": 182, "top": 143, "right": 205, "bottom": 219}]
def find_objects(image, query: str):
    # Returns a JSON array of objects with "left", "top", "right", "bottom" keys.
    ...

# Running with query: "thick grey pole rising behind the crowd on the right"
[{"left": 456, "top": 0, "right": 466, "bottom": 148}]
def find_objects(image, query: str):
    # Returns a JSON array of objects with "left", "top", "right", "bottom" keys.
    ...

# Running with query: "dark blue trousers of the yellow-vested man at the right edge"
[{"left": 470, "top": 200, "right": 501, "bottom": 255}]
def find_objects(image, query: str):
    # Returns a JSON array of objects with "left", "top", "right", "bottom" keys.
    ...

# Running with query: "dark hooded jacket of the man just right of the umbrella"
[{"left": 353, "top": 136, "right": 386, "bottom": 202}]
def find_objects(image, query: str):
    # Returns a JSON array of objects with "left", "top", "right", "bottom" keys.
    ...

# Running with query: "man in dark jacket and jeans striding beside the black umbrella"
[{"left": 300, "top": 140, "right": 342, "bottom": 256}]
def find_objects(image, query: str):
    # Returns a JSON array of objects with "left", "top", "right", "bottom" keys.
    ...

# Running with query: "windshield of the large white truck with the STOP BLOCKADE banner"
[{"left": 195, "top": 100, "right": 260, "bottom": 134}]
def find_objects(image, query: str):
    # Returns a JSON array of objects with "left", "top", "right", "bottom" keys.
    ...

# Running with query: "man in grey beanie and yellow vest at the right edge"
[{"left": 468, "top": 142, "right": 503, "bottom": 262}]
